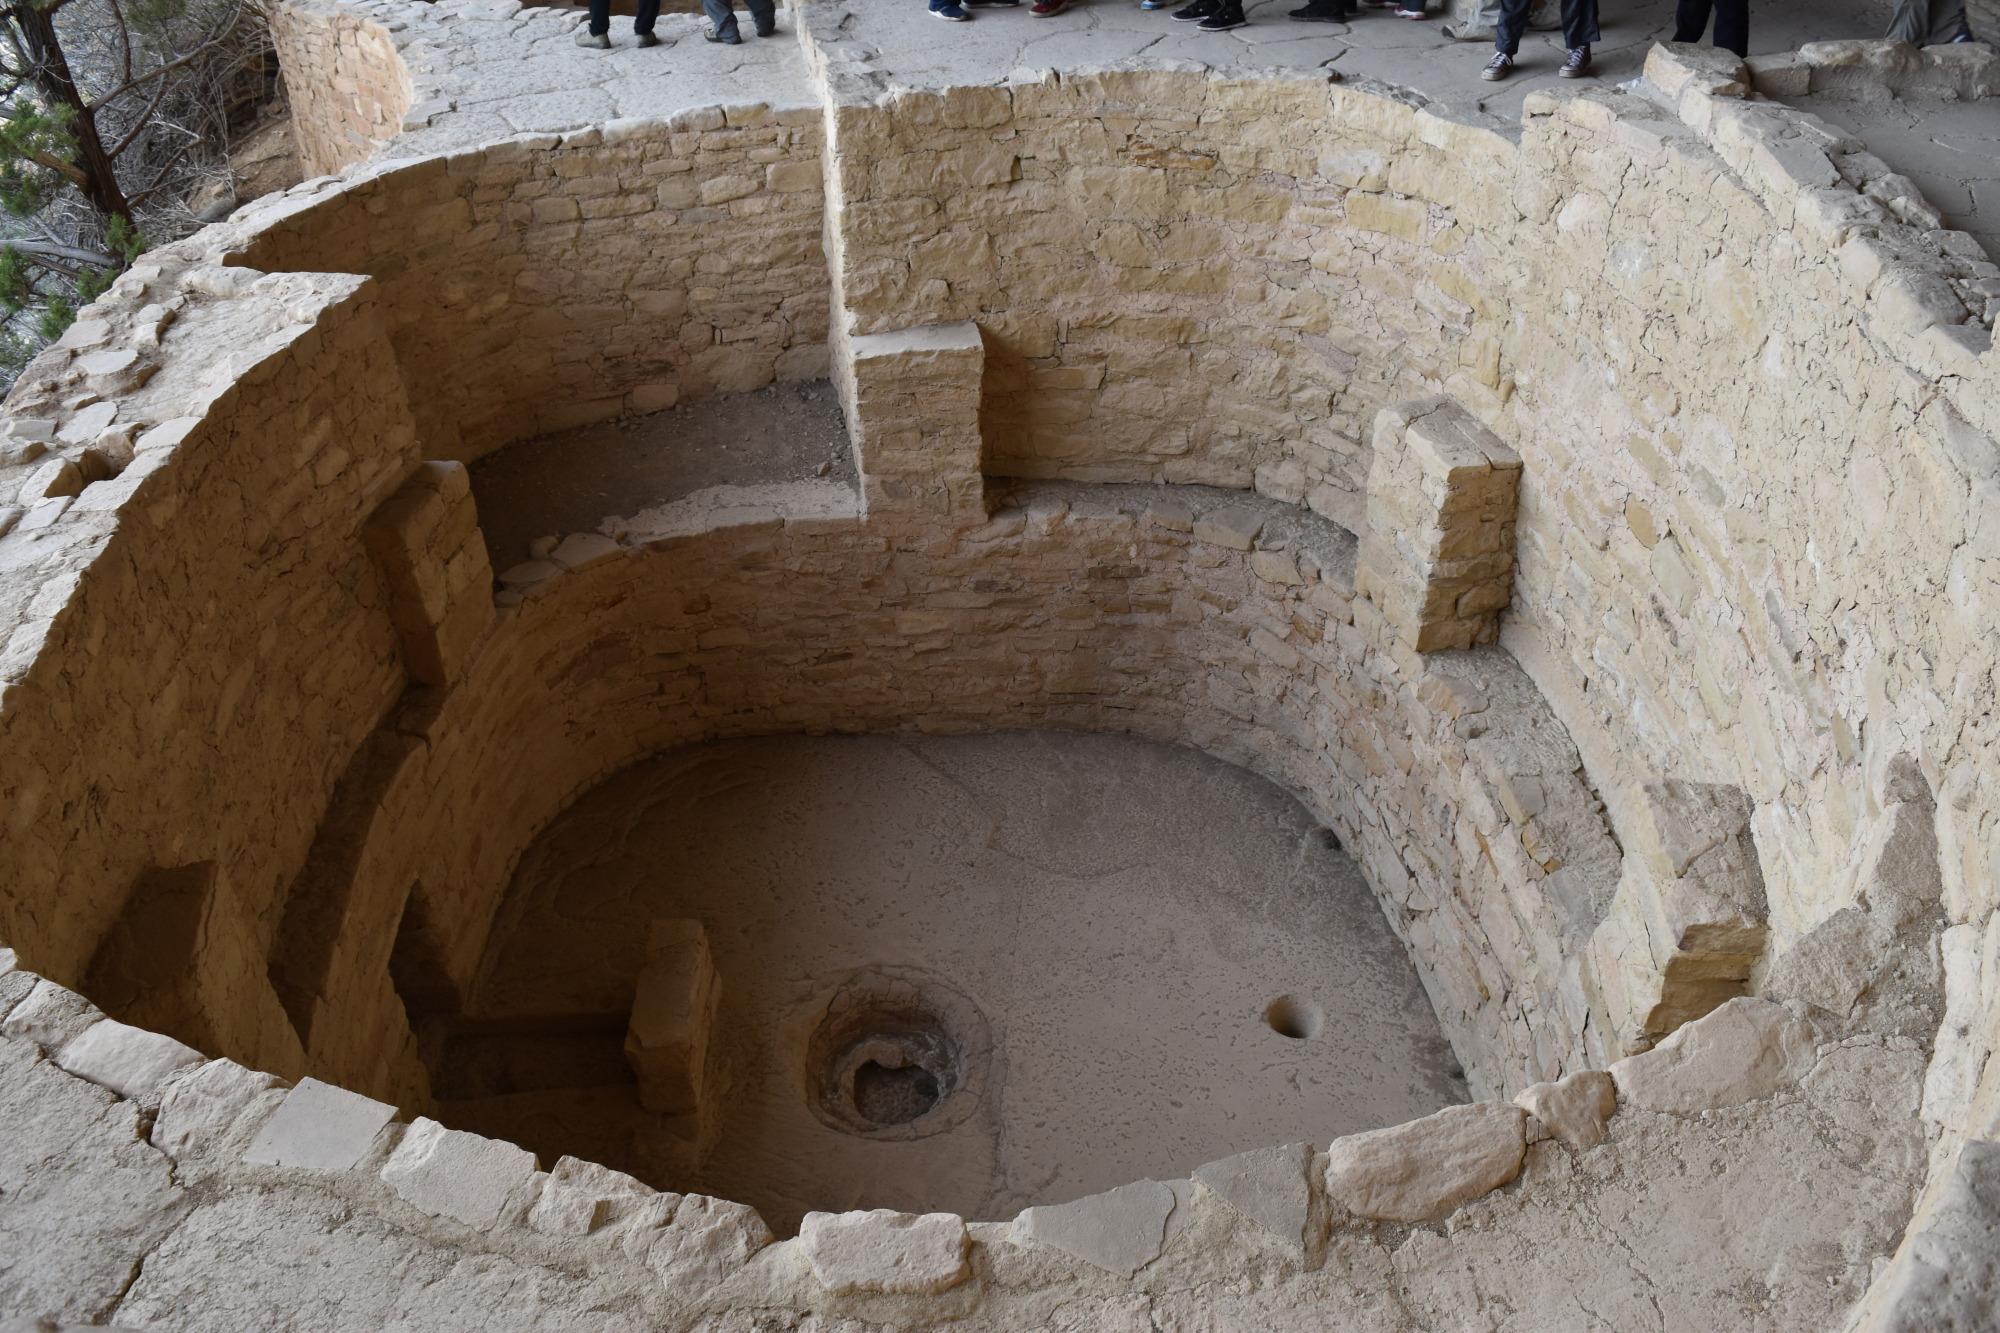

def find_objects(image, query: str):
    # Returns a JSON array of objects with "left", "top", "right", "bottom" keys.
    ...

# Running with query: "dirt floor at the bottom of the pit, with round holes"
[{"left": 434, "top": 733, "right": 1466, "bottom": 1231}]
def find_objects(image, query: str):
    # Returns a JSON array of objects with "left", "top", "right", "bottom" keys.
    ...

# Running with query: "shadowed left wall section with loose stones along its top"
[{"left": 0, "top": 252, "right": 430, "bottom": 1071}]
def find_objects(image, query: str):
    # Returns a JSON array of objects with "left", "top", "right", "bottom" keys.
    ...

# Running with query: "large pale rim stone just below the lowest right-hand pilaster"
[{"left": 1608, "top": 995, "right": 1818, "bottom": 1115}]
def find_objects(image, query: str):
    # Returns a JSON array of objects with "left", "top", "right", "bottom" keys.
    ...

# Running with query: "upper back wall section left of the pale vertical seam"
[{"left": 234, "top": 115, "right": 828, "bottom": 460}]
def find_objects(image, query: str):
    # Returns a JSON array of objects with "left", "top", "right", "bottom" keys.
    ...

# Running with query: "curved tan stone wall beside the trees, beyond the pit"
[{"left": 268, "top": 0, "right": 416, "bottom": 176}]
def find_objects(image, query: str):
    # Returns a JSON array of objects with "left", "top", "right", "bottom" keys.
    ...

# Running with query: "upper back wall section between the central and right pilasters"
[{"left": 804, "top": 29, "right": 1508, "bottom": 526}]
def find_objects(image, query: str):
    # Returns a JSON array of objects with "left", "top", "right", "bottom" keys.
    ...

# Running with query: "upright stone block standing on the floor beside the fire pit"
[{"left": 624, "top": 919, "right": 722, "bottom": 1115}]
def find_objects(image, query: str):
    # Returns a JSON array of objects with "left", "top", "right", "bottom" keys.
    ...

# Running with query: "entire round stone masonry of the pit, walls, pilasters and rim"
[{"left": 0, "top": 4, "right": 2000, "bottom": 1329}]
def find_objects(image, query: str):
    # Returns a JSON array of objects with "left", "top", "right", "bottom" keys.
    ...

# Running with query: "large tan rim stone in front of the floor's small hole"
[{"left": 1326, "top": 1101, "right": 1528, "bottom": 1223}]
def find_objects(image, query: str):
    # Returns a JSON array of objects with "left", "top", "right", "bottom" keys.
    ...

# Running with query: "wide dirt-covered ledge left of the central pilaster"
[{"left": 472, "top": 380, "right": 854, "bottom": 572}]
